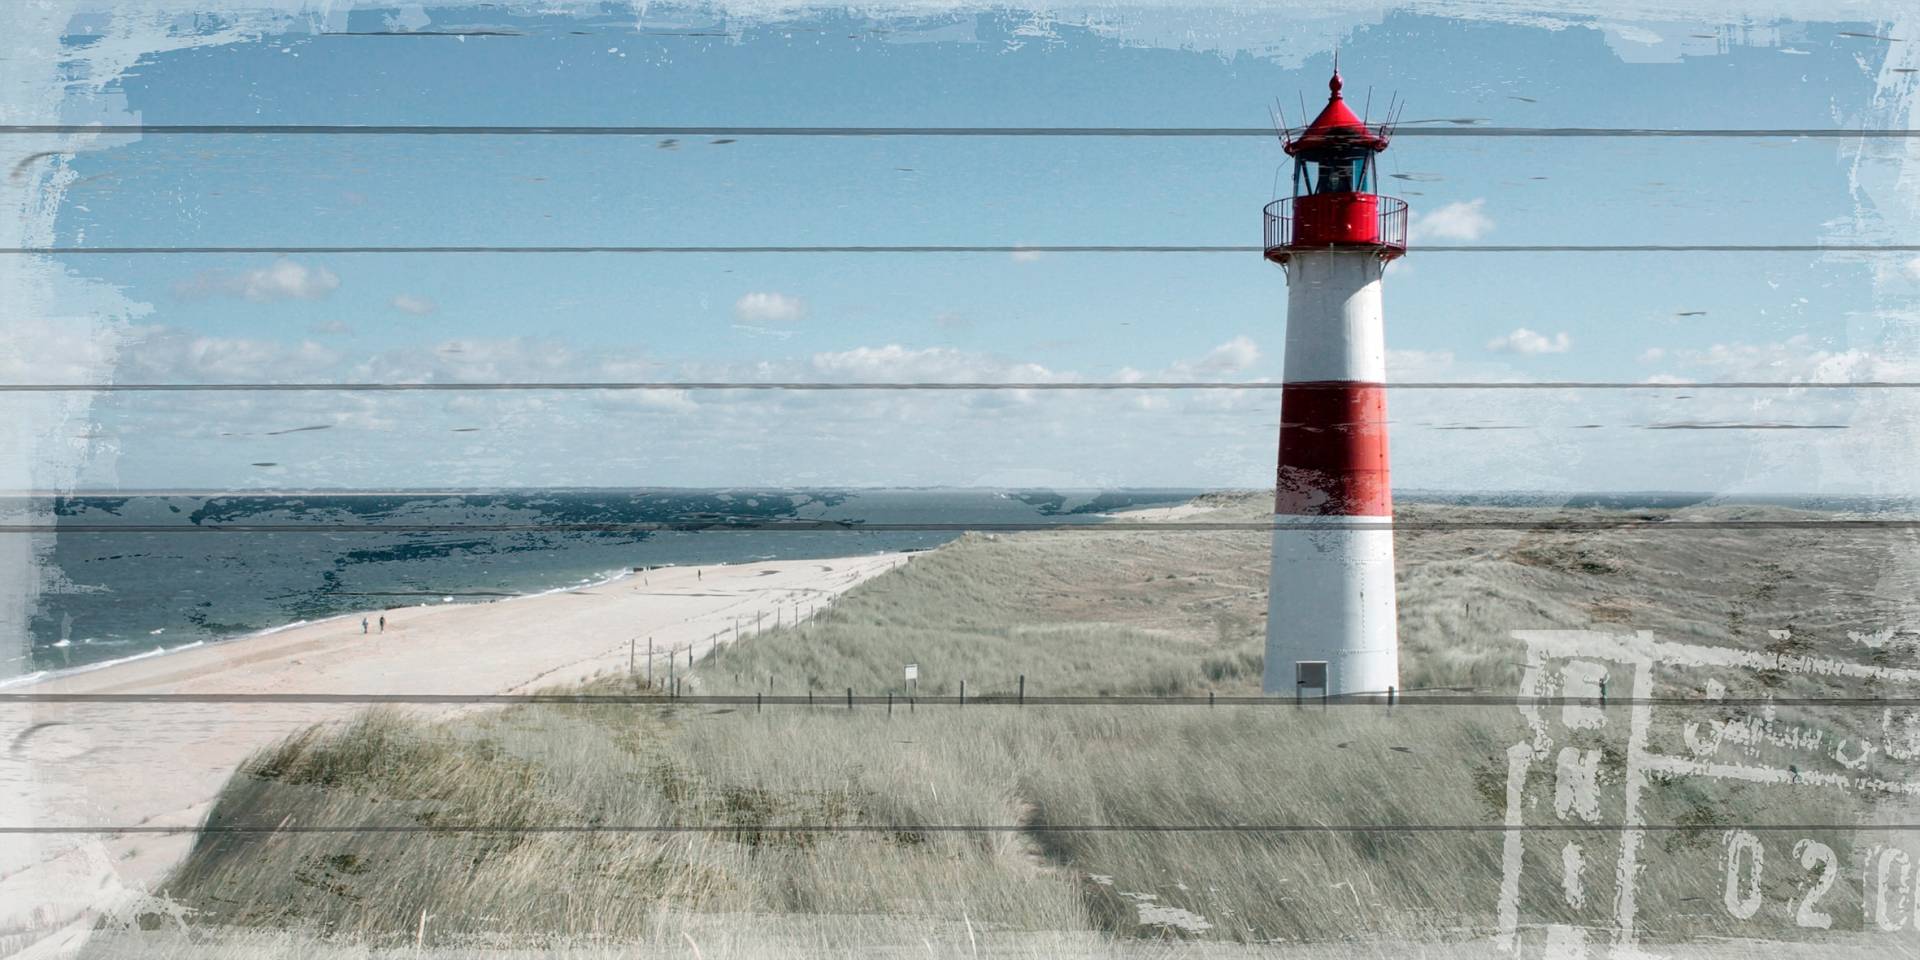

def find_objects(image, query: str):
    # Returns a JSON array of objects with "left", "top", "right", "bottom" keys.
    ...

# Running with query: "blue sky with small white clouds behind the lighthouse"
[{"left": 8, "top": 4, "right": 1920, "bottom": 493}]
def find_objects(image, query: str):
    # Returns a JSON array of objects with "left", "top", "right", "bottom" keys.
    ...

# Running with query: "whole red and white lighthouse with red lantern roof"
[{"left": 1261, "top": 65, "right": 1407, "bottom": 697}]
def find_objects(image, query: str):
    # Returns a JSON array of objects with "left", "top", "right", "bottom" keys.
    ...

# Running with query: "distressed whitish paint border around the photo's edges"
[{"left": 0, "top": 0, "right": 1920, "bottom": 948}]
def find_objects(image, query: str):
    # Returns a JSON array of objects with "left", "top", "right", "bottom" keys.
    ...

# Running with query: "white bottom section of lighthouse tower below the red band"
[{"left": 1261, "top": 516, "right": 1400, "bottom": 699}]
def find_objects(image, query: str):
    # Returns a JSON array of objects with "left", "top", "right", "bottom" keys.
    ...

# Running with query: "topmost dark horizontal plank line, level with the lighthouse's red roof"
[{"left": 0, "top": 119, "right": 1920, "bottom": 140}]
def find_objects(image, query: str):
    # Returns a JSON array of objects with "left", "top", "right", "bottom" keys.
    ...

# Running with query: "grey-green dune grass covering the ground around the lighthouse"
[{"left": 116, "top": 499, "right": 1910, "bottom": 956}]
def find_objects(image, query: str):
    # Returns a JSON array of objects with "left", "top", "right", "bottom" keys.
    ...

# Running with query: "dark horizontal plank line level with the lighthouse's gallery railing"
[{"left": 0, "top": 244, "right": 1920, "bottom": 257}]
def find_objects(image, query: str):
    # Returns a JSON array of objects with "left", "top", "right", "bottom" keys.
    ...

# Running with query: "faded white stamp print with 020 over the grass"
[{"left": 1496, "top": 630, "right": 1920, "bottom": 960}]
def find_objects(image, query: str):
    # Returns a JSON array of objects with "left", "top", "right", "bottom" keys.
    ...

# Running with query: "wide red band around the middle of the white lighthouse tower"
[{"left": 1273, "top": 380, "right": 1394, "bottom": 516}]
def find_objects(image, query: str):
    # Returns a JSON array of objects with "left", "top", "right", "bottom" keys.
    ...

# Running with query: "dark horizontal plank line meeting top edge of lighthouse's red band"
[{"left": 0, "top": 380, "right": 1920, "bottom": 394}]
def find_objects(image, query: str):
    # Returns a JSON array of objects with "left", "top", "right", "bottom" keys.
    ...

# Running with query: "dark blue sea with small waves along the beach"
[{"left": 15, "top": 490, "right": 1198, "bottom": 682}]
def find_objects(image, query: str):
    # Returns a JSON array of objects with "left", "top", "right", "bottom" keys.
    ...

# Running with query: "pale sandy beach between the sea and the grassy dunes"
[{"left": 0, "top": 553, "right": 908, "bottom": 956}]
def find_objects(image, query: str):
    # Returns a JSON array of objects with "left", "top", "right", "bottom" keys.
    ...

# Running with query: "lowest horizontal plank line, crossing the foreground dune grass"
[{"left": 0, "top": 822, "right": 1889, "bottom": 837}]
